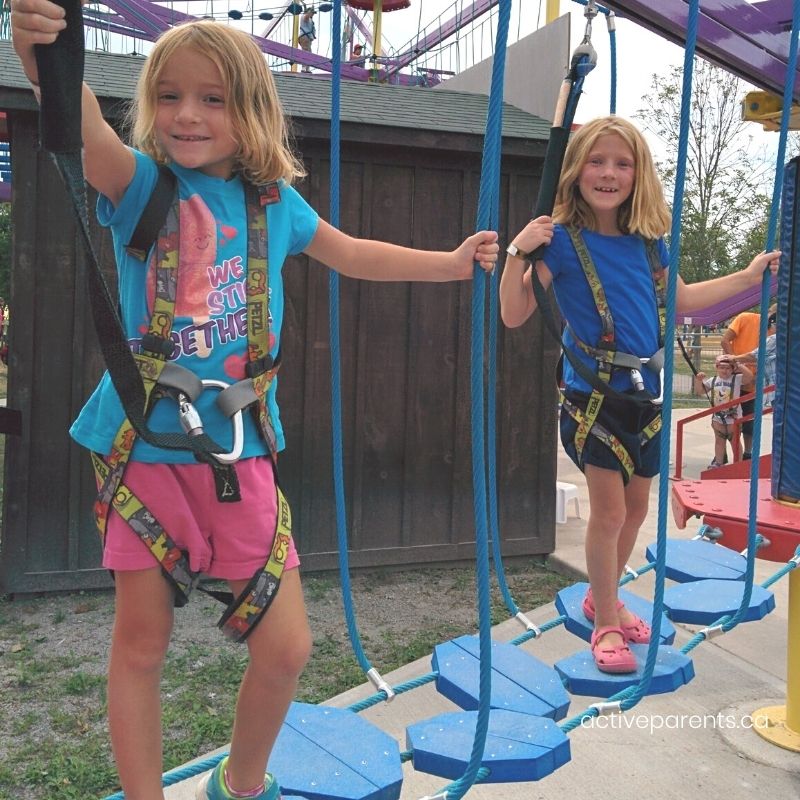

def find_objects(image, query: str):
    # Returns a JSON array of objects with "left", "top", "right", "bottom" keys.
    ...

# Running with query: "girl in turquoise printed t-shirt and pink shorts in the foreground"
[{"left": 11, "top": 7, "right": 498, "bottom": 800}]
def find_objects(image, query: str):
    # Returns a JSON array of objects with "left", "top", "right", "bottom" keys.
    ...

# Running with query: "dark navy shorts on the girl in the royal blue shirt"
[{"left": 559, "top": 391, "right": 661, "bottom": 483}]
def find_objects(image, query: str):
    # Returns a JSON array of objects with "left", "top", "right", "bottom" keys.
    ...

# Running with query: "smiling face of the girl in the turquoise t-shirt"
[{"left": 155, "top": 47, "right": 239, "bottom": 179}]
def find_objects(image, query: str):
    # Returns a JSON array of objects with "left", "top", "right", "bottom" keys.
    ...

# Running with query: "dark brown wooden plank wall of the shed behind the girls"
[{"left": 0, "top": 111, "right": 557, "bottom": 592}]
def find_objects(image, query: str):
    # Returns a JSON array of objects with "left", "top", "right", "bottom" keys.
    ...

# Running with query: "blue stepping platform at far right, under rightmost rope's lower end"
[{"left": 664, "top": 580, "right": 775, "bottom": 625}]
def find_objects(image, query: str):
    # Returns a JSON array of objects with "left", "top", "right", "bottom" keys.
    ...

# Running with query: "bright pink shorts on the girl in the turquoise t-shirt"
[{"left": 103, "top": 456, "right": 300, "bottom": 580}]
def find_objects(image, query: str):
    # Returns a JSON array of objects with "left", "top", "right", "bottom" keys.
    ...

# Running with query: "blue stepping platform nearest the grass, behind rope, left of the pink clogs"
[{"left": 433, "top": 636, "right": 569, "bottom": 720}]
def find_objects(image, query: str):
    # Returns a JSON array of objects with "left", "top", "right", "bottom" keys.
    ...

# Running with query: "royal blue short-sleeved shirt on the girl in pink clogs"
[{"left": 542, "top": 225, "right": 669, "bottom": 394}]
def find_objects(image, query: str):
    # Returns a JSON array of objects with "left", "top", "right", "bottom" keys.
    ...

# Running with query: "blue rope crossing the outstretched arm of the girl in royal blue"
[{"left": 620, "top": 0, "right": 700, "bottom": 710}]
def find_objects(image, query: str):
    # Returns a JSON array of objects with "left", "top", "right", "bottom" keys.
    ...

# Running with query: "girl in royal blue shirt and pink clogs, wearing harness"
[{"left": 500, "top": 116, "right": 780, "bottom": 673}]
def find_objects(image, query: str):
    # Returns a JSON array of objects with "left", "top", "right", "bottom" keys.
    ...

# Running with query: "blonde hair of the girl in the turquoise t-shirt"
[{"left": 129, "top": 20, "right": 305, "bottom": 183}]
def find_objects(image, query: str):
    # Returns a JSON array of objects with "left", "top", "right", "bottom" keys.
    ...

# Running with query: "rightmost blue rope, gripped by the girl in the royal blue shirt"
[{"left": 722, "top": 0, "right": 800, "bottom": 631}]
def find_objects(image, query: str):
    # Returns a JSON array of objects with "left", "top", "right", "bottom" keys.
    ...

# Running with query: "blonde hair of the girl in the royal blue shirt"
[{"left": 553, "top": 116, "right": 671, "bottom": 239}]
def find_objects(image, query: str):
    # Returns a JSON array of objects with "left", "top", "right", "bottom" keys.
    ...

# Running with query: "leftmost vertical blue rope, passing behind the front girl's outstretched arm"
[{"left": 328, "top": 0, "right": 372, "bottom": 672}]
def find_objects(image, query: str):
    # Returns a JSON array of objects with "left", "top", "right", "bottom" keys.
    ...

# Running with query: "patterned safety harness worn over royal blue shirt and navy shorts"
[{"left": 561, "top": 227, "right": 667, "bottom": 482}]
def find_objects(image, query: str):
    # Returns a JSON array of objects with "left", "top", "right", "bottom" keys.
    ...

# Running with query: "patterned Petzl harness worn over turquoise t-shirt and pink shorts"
[{"left": 92, "top": 167, "right": 292, "bottom": 642}]
